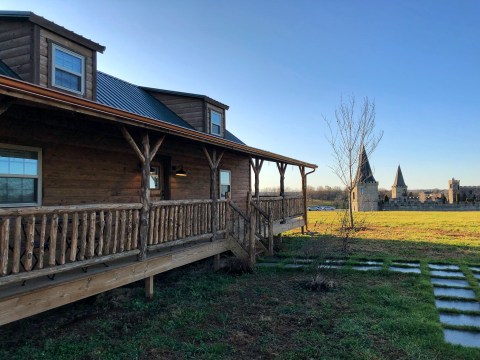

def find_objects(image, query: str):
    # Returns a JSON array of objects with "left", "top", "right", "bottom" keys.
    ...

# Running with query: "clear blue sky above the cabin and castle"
[{"left": 0, "top": 0, "right": 480, "bottom": 189}]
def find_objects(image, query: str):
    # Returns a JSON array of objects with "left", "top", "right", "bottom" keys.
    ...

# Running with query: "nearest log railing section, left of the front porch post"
[{"left": 0, "top": 204, "right": 141, "bottom": 285}]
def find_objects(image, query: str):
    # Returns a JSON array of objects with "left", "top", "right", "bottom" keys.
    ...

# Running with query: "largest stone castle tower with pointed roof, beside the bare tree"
[{"left": 351, "top": 147, "right": 378, "bottom": 211}]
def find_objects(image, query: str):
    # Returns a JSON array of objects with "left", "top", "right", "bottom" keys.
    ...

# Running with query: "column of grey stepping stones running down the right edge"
[{"left": 428, "top": 264, "right": 480, "bottom": 347}]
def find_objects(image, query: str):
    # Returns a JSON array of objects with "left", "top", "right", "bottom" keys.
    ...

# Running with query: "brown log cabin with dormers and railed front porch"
[{"left": 0, "top": 11, "right": 316, "bottom": 325}]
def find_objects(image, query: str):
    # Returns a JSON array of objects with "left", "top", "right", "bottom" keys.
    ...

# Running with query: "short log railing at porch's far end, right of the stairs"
[{"left": 258, "top": 196, "right": 305, "bottom": 221}]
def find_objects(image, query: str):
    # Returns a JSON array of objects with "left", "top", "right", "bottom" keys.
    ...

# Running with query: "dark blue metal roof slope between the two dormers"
[{"left": 97, "top": 71, "right": 194, "bottom": 130}]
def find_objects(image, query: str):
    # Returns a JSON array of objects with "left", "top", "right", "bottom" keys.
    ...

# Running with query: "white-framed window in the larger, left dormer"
[{"left": 52, "top": 44, "right": 85, "bottom": 94}]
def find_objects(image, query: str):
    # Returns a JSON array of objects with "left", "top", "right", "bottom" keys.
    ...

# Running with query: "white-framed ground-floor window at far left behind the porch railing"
[{"left": 0, "top": 145, "right": 42, "bottom": 206}]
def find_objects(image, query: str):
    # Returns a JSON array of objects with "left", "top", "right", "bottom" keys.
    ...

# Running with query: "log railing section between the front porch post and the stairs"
[{"left": 148, "top": 200, "right": 227, "bottom": 250}]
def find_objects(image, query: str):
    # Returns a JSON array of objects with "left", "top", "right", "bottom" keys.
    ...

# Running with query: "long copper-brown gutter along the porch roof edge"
[{"left": 0, "top": 75, "right": 317, "bottom": 169}]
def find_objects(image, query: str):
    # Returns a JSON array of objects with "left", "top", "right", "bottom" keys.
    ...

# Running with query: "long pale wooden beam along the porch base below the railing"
[{"left": 0, "top": 239, "right": 232, "bottom": 326}]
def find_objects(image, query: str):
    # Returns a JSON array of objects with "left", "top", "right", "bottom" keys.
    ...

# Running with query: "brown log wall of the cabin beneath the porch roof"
[{"left": 0, "top": 105, "right": 250, "bottom": 210}]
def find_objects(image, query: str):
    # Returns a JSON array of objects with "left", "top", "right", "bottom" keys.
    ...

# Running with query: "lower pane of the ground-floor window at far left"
[{"left": 0, "top": 177, "right": 38, "bottom": 204}]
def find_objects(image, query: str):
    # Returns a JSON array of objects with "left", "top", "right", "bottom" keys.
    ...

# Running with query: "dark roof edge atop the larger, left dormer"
[{"left": 0, "top": 10, "right": 105, "bottom": 53}]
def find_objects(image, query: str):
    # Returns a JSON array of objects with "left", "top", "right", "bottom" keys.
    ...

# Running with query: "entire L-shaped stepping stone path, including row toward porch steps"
[{"left": 257, "top": 259, "right": 480, "bottom": 347}]
